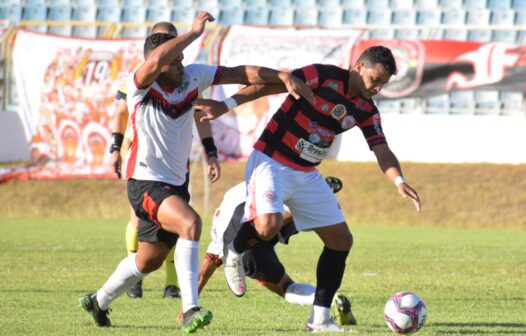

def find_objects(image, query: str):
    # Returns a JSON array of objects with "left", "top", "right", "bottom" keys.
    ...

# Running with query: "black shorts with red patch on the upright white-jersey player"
[{"left": 128, "top": 178, "right": 190, "bottom": 248}]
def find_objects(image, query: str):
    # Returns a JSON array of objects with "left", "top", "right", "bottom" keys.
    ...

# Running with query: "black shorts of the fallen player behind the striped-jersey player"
[{"left": 243, "top": 243, "right": 285, "bottom": 284}]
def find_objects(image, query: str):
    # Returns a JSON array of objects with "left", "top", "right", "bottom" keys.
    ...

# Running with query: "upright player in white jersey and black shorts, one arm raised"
[{"left": 80, "top": 12, "right": 314, "bottom": 333}]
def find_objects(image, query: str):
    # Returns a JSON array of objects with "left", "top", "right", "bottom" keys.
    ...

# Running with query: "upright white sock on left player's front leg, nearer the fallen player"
[{"left": 174, "top": 238, "right": 199, "bottom": 312}]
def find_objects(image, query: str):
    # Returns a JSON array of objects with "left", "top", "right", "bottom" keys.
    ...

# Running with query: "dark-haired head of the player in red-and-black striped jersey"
[{"left": 352, "top": 46, "right": 397, "bottom": 99}]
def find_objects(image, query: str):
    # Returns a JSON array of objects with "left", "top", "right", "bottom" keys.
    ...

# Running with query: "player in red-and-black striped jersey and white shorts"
[{"left": 198, "top": 46, "right": 420, "bottom": 332}]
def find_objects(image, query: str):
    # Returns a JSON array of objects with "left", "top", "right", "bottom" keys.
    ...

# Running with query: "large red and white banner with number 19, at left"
[{"left": 4, "top": 30, "right": 202, "bottom": 180}]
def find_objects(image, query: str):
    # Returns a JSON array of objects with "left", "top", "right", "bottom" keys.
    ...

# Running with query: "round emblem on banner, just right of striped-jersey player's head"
[{"left": 380, "top": 40, "right": 425, "bottom": 98}]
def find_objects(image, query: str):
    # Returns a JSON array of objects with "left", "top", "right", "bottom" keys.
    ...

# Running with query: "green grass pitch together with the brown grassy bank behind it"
[{"left": 0, "top": 161, "right": 526, "bottom": 336}]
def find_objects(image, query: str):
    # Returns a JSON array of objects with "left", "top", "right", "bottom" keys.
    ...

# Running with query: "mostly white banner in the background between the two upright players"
[{"left": 212, "top": 26, "right": 361, "bottom": 160}]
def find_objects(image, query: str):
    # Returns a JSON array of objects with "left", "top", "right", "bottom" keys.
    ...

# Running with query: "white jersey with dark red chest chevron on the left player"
[{"left": 126, "top": 64, "right": 222, "bottom": 185}]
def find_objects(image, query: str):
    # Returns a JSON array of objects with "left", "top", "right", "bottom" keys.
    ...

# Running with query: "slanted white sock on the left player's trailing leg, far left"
[{"left": 97, "top": 253, "right": 146, "bottom": 310}]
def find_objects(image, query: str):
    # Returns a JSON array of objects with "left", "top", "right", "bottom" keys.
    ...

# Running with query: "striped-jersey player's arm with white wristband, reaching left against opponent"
[{"left": 194, "top": 84, "right": 287, "bottom": 122}]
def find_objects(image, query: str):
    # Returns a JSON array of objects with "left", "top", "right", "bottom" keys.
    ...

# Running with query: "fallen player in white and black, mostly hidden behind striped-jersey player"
[{"left": 194, "top": 176, "right": 356, "bottom": 325}]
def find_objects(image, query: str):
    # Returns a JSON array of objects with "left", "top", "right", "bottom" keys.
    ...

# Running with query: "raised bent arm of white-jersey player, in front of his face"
[{"left": 135, "top": 11, "right": 215, "bottom": 87}]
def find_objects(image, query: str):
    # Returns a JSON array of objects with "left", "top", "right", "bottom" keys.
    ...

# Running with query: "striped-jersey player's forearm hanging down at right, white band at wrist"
[{"left": 373, "top": 144, "right": 422, "bottom": 211}]
